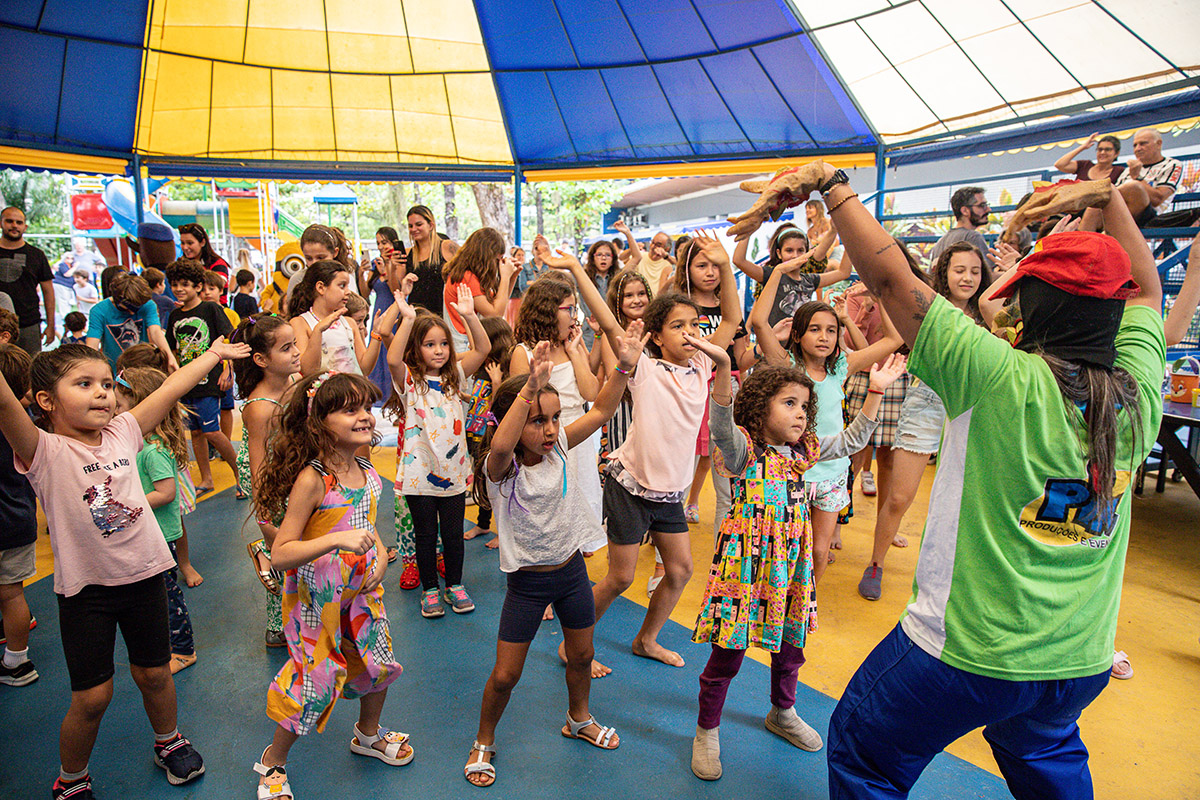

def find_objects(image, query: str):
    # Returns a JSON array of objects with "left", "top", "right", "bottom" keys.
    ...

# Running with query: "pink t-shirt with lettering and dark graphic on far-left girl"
[{"left": 13, "top": 414, "right": 175, "bottom": 597}]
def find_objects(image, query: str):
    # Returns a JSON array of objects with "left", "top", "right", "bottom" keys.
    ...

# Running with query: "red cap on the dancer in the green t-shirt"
[{"left": 991, "top": 230, "right": 1141, "bottom": 300}]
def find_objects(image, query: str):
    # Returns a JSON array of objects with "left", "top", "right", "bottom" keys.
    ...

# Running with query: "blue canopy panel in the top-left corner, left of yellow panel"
[{"left": 0, "top": 0, "right": 148, "bottom": 155}]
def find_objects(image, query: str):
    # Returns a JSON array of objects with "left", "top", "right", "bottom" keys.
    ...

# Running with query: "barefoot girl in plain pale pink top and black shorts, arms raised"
[{"left": 544, "top": 231, "right": 742, "bottom": 676}]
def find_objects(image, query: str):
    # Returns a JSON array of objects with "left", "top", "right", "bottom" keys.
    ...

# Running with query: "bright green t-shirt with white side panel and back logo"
[{"left": 901, "top": 297, "right": 1166, "bottom": 680}]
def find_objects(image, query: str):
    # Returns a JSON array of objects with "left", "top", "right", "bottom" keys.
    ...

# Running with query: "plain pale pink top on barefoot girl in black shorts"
[{"left": 608, "top": 353, "right": 713, "bottom": 493}]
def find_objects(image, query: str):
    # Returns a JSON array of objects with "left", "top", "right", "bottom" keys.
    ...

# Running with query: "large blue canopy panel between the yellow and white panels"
[{"left": 475, "top": 0, "right": 876, "bottom": 167}]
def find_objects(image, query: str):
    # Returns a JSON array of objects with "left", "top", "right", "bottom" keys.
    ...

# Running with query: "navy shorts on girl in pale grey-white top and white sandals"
[{"left": 499, "top": 553, "right": 596, "bottom": 644}]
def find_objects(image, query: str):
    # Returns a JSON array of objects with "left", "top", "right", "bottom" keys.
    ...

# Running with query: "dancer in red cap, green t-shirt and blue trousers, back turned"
[{"left": 804, "top": 166, "right": 1166, "bottom": 800}]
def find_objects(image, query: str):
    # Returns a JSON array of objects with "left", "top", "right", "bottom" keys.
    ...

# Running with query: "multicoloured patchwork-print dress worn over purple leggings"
[{"left": 691, "top": 427, "right": 821, "bottom": 652}]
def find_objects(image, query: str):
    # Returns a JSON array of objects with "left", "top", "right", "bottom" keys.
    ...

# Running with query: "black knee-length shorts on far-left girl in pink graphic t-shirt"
[{"left": 58, "top": 575, "right": 170, "bottom": 692}]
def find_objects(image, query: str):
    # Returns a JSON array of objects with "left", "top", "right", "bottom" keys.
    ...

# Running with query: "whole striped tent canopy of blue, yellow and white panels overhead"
[{"left": 0, "top": 0, "right": 1200, "bottom": 179}]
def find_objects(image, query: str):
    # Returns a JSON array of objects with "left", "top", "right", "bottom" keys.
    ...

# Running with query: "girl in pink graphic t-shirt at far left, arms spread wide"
[{"left": 0, "top": 339, "right": 250, "bottom": 798}]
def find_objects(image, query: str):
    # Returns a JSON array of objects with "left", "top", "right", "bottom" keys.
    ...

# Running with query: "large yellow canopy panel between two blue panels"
[{"left": 134, "top": 0, "right": 512, "bottom": 164}]
